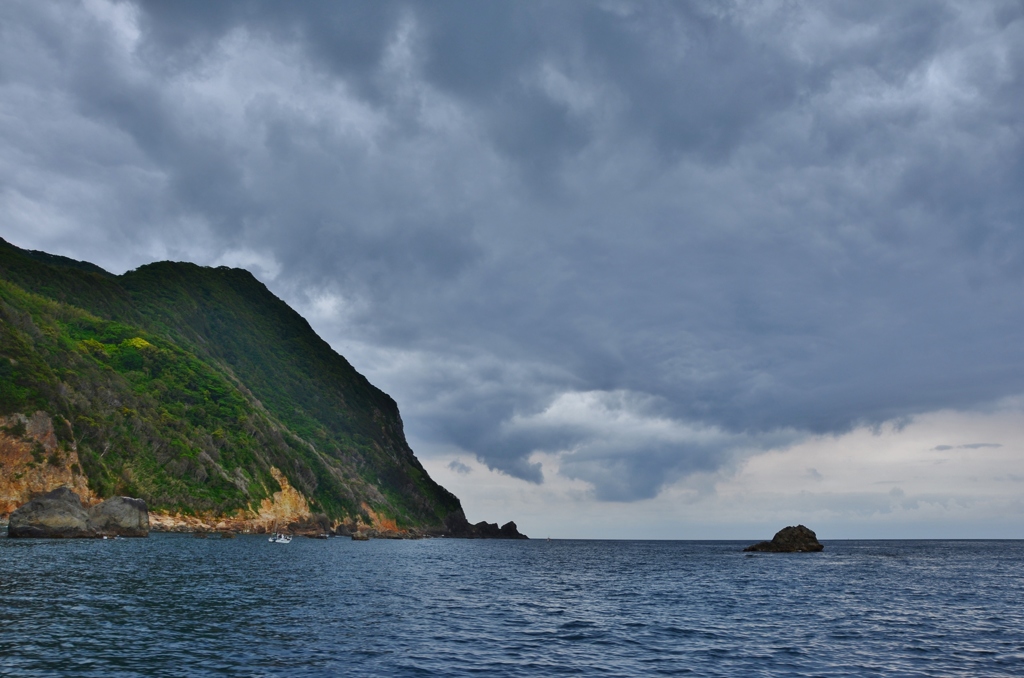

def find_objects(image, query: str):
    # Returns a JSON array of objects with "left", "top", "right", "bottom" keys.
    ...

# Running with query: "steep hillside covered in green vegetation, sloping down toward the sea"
[{"left": 0, "top": 240, "right": 461, "bottom": 527}]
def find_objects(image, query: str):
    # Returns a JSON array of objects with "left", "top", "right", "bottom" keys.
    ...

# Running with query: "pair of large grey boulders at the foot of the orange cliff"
[{"left": 7, "top": 488, "right": 150, "bottom": 539}]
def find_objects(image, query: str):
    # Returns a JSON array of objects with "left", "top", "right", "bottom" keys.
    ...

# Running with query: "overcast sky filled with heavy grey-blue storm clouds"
[{"left": 0, "top": 0, "right": 1024, "bottom": 539}]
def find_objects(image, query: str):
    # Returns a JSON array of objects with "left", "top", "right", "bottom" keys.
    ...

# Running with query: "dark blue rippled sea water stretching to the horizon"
[{"left": 0, "top": 535, "right": 1024, "bottom": 676}]
